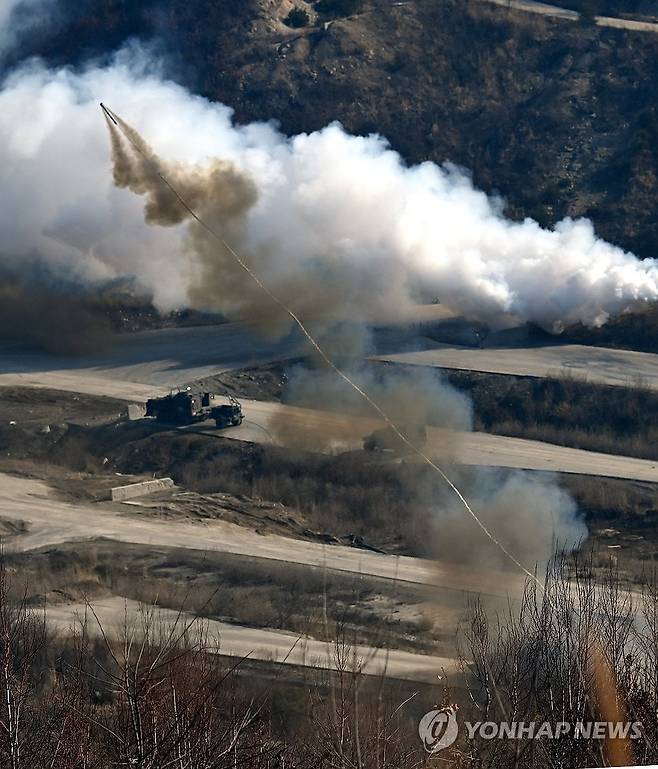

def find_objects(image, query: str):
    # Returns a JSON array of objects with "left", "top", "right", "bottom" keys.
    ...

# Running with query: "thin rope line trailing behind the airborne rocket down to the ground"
[{"left": 101, "top": 105, "right": 544, "bottom": 593}]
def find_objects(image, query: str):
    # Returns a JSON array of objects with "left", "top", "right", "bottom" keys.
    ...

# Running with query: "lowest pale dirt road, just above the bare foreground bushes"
[{"left": 46, "top": 597, "right": 457, "bottom": 683}]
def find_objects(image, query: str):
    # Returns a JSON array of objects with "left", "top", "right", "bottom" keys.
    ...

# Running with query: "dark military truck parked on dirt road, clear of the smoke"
[{"left": 146, "top": 387, "right": 244, "bottom": 428}]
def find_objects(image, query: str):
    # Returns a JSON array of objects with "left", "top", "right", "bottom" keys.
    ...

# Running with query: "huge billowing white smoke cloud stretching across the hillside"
[{"left": 0, "top": 47, "right": 658, "bottom": 328}]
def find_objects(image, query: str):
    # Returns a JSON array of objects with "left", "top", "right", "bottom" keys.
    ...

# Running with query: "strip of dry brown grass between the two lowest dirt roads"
[{"left": 5, "top": 541, "right": 446, "bottom": 653}]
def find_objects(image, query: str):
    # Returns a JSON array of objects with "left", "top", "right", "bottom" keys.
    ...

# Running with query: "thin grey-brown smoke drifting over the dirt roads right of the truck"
[{"left": 269, "top": 356, "right": 587, "bottom": 572}]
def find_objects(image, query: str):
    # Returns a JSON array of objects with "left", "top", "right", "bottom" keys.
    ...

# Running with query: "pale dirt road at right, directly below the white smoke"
[{"left": 374, "top": 344, "right": 658, "bottom": 389}]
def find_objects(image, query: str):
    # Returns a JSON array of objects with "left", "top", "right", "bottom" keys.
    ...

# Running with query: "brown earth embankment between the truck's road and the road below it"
[{"left": 0, "top": 384, "right": 410, "bottom": 552}]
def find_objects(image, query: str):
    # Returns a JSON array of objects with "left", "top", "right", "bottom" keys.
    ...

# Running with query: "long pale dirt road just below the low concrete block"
[{"left": 0, "top": 474, "right": 522, "bottom": 597}]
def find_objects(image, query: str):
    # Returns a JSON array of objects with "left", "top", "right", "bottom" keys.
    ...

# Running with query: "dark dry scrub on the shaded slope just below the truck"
[{"left": 0, "top": 414, "right": 436, "bottom": 553}]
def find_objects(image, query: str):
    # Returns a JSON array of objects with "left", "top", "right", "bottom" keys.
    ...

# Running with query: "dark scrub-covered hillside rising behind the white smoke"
[{"left": 10, "top": 0, "right": 658, "bottom": 257}]
